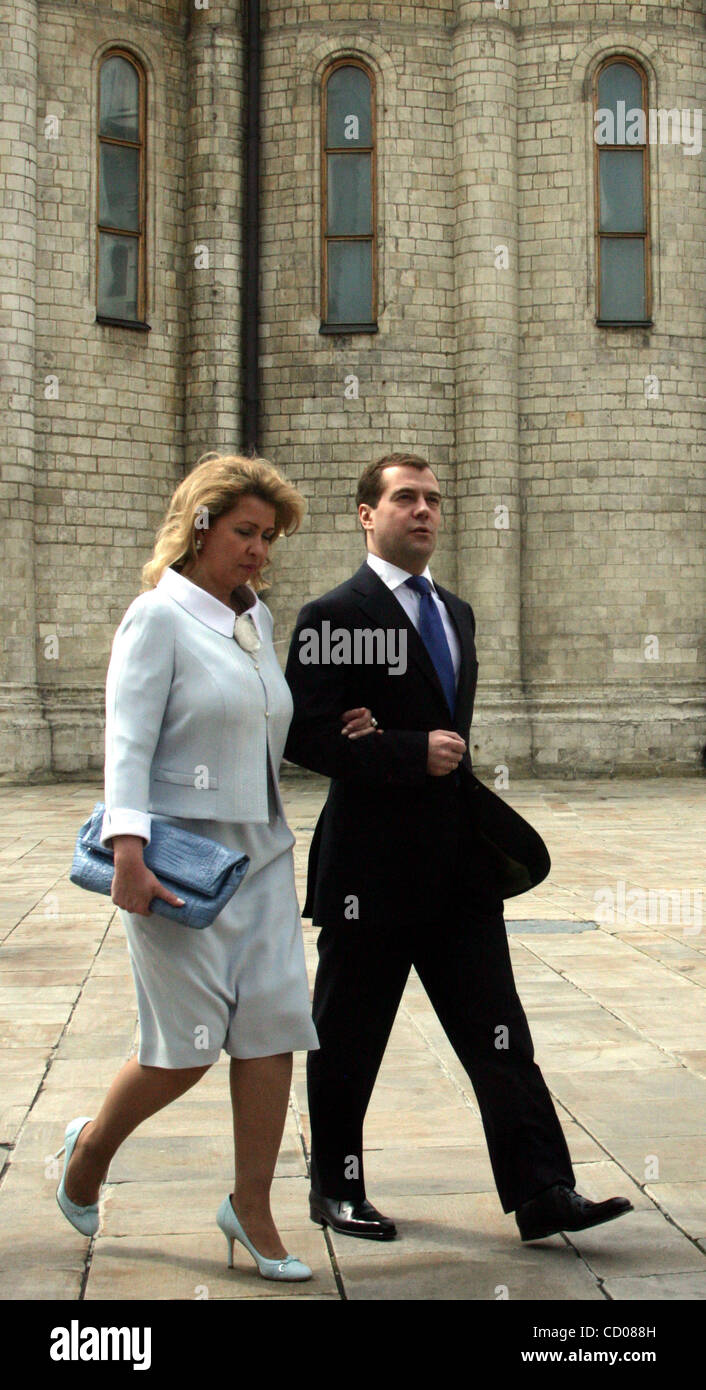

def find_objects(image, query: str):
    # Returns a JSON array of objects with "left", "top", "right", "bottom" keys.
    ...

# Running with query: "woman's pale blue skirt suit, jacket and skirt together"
[{"left": 101, "top": 569, "right": 318, "bottom": 1068}]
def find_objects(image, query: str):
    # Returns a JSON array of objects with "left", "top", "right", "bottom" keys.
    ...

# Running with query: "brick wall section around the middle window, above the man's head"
[{"left": 261, "top": 3, "right": 456, "bottom": 651}]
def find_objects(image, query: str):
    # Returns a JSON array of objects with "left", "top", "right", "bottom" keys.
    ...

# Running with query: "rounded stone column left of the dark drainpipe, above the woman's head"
[{"left": 185, "top": 0, "right": 245, "bottom": 470}]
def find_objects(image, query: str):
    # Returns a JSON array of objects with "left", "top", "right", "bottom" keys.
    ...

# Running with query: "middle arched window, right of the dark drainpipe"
[{"left": 321, "top": 58, "right": 377, "bottom": 332}]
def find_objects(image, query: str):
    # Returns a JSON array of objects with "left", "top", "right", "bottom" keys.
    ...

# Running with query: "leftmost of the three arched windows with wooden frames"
[{"left": 96, "top": 50, "right": 146, "bottom": 325}]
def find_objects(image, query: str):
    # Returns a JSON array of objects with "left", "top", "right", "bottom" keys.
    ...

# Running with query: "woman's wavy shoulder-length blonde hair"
[{"left": 142, "top": 453, "right": 304, "bottom": 591}]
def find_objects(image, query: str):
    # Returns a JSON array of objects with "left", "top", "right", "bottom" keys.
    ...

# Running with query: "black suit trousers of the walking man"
[{"left": 307, "top": 878, "right": 574, "bottom": 1212}]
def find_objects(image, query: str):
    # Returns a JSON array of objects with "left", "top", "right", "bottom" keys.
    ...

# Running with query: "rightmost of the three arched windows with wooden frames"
[{"left": 593, "top": 57, "right": 650, "bottom": 325}]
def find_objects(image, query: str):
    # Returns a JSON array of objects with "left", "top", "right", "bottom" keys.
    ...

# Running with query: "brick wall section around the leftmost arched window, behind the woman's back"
[{"left": 35, "top": 0, "right": 186, "bottom": 771}]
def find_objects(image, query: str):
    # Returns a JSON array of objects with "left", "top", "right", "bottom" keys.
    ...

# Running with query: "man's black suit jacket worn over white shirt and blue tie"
[{"left": 285, "top": 564, "right": 549, "bottom": 927}]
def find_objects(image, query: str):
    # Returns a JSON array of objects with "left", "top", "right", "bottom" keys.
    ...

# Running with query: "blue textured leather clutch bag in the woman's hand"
[{"left": 69, "top": 802, "right": 250, "bottom": 930}]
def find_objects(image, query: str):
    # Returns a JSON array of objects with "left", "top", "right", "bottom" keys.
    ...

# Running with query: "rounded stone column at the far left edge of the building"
[{"left": 0, "top": 0, "right": 50, "bottom": 780}]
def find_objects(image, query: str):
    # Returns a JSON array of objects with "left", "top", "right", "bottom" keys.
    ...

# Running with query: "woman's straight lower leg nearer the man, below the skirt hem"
[{"left": 231, "top": 1052, "right": 292, "bottom": 1259}]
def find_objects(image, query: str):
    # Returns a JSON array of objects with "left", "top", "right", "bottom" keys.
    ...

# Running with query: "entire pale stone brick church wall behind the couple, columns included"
[{"left": 0, "top": 0, "right": 706, "bottom": 777}]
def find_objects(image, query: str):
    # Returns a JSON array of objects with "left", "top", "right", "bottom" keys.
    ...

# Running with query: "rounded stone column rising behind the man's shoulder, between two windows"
[{"left": 453, "top": 0, "right": 530, "bottom": 773}]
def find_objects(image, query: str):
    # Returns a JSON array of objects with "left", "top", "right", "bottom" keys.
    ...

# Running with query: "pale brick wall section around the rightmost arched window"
[{"left": 518, "top": 4, "right": 706, "bottom": 770}]
